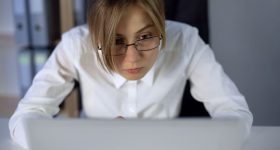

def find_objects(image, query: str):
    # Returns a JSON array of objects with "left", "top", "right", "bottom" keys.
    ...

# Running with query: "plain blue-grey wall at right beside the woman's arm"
[{"left": 209, "top": 0, "right": 280, "bottom": 125}]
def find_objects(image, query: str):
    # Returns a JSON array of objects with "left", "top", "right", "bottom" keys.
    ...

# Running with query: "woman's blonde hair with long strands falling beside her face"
[{"left": 87, "top": 0, "right": 166, "bottom": 72}]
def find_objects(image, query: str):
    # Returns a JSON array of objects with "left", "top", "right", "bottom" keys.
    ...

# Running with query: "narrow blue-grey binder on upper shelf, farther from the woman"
[{"left": 12, "top": 0, "right": 31, "bottom": 47}]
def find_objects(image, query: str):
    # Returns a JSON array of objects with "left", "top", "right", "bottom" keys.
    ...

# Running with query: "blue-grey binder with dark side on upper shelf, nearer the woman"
[{"left": 29, "top": 0, "right": 60, "bottom": 47}]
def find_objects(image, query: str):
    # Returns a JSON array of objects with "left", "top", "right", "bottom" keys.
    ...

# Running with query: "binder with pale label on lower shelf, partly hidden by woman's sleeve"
[{"left": 33, "top": 49, "right": 50, "bottom": 75}]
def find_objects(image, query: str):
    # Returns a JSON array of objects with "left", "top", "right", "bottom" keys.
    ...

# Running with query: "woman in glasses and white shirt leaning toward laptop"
[{"left": 9, "top": 0, "right": 252, "bottom": 147}]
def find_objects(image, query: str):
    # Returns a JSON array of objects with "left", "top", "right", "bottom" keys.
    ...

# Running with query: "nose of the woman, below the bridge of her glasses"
[{"left": 125, "top": 44, "right": 141, "bottom": 63}]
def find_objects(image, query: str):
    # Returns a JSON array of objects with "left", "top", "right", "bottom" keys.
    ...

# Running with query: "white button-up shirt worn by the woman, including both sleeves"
[{"left": 9, "top": 21, "right": 252, "bottom": 147}]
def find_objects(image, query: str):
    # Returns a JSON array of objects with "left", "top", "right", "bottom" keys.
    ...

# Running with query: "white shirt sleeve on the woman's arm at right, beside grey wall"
[{"left": 187, "top": 29, "right": 253, "bottom": 137}]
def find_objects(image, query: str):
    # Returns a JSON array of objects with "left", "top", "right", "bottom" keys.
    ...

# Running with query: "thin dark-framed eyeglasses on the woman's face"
[{"left": 112, "top": 35, "right": 162, "bottom": 56}]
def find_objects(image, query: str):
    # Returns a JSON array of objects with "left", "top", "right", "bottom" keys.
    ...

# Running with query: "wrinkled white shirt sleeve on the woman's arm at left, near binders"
[{"left": 9, "top": 32, "right": 77, "bottom": 148}]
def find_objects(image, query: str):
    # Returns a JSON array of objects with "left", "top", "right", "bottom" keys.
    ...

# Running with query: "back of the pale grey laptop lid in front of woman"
[{"left": 26, "top": 119, "right": 244, "bottom": 150}]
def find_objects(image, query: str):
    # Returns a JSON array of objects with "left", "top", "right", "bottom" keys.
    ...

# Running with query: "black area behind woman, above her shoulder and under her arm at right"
[{"left": 165, "top": 0, "right": 209, "bottom": 117}]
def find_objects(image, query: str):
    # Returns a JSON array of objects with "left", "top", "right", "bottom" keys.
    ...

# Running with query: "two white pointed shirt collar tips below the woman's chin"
[{"left": 113, "top": 65, "right": 155, "bottom": 89}]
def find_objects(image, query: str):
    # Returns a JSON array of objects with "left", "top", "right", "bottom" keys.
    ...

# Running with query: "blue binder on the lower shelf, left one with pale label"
[{"left": 18, "top": 49, "right": 33, "bottom": 96}]
